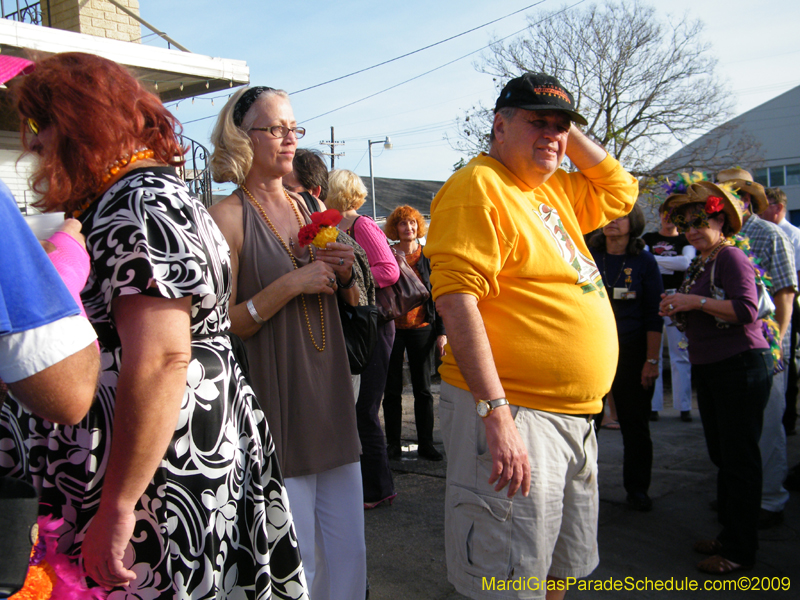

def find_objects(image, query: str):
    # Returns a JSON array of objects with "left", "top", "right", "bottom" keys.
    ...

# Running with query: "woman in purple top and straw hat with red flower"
[{"left": 660, "top": 180, "right": 773, "bottom": 575}]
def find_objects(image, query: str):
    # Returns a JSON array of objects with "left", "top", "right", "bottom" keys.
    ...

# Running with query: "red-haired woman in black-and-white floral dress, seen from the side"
[{"left": 5, "top": 53, "right": 306, "bottom": 598}]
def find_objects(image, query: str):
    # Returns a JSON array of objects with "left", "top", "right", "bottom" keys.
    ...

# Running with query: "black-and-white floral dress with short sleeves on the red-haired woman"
[{"left": 0, "top": 167, "right": 307, "bottom": 600}]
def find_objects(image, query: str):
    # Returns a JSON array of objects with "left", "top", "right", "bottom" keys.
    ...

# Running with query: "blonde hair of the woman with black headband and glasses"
[{"left": 210, "top": 87, "right": 289, "bottom": 185}]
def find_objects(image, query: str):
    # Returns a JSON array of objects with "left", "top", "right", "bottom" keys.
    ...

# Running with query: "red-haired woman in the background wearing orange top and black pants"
[{"left": 383, "top": 206, "right": 447, "bottom": 461}]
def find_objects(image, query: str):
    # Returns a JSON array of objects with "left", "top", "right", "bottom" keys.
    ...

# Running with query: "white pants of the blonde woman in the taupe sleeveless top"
[{"left": 284, "top": 462, "right": 367, "bottom": 600}]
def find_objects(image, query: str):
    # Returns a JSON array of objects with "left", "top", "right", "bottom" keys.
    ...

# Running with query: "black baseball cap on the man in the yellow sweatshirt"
[{"left": 494, "top": 73, "right": 588, "bottom": 125}]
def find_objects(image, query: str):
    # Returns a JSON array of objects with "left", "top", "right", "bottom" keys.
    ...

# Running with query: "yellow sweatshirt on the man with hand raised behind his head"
[{"left": 424, "top": 154, "right": 638, "bottom": 414}]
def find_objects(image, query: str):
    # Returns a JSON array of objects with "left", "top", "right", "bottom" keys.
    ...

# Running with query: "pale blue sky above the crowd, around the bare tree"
[{"left": 139, "top": 0, "right": 800, "bottom": 188}]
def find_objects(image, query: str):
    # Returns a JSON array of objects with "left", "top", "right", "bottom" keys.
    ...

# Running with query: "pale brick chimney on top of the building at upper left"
[{"left": 41, "top": 0, "right": 142, "bottom": 42}]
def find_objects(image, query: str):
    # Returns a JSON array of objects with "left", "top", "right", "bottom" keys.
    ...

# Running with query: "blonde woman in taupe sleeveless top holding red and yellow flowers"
[{"left": 210, "top": 87, "right": 367, "bottom": 600}]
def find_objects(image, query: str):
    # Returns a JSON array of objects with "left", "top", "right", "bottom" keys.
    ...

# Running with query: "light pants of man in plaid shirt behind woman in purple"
[{"left": 758, "top": 366, "right": 789, "bottom": 512}]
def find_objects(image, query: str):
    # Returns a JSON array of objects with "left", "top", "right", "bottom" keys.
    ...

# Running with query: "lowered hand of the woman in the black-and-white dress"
[{"left": 81, "top": 505, "right": 136, "bottom": 589}]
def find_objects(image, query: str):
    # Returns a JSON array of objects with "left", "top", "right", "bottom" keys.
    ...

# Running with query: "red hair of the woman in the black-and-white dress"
[{"left": 14, "top": 52, "right": 184, "bottom": 213}]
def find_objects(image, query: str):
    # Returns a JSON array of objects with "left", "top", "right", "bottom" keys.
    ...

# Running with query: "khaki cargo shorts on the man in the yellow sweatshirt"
[{"left": 439, "top": 382, "right": 599, "bottom": 599}]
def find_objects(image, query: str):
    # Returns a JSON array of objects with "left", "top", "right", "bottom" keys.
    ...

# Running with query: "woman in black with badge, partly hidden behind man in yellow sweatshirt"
[{"left": 589, "top": 204, "right": 664, "bottom": 511}]
